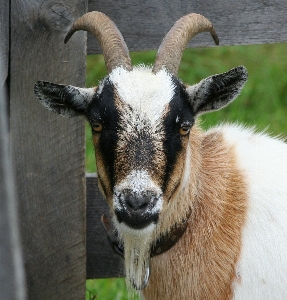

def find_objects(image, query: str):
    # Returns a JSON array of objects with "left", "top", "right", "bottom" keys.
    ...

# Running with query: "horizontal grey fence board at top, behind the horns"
[{"left": 88, "top": 0, "right": 287, "bottom": 54}]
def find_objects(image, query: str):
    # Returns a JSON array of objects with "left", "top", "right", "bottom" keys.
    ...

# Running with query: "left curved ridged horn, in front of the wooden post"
[{"left": 65, "top": 11, "right": 132, "bottom": 73}]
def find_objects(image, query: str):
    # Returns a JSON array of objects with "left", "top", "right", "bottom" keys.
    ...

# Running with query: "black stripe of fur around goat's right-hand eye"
[{"left": 163, "top": 77, "right": 195, "bottom": 190}]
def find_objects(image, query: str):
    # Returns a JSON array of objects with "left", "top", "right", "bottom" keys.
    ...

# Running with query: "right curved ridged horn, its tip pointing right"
[{"left": 153, "top": 14, "right": 219, "bottom": 75}]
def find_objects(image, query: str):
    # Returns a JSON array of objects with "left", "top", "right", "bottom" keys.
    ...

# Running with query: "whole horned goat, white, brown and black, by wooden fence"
[{"left": 35, "top": 12, "right": 287, "bottom": 300}]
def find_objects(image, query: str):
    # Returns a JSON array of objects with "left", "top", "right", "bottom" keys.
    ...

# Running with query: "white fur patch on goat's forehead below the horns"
[{"left": 109, "top": 65, "right": 174, "bottom": 126}]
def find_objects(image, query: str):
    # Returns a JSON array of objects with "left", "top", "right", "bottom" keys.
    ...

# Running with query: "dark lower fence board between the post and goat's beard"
[{"left": 86, "top": 174, "right": 124, "bottom": 279}]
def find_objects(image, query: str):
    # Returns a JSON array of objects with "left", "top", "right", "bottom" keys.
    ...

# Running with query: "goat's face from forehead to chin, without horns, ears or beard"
[{"left": 91, "top": 67, "right": 194, "bottom": 229}]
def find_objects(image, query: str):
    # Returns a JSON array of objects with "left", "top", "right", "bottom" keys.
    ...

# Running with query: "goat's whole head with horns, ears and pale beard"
[{"left": 35, "top": 12, "right": 247, "bottom": 289}]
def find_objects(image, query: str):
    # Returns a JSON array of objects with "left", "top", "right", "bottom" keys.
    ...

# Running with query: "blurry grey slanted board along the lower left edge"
[{"left": 0, "top": 89, "right": 26, "bottom": 300}]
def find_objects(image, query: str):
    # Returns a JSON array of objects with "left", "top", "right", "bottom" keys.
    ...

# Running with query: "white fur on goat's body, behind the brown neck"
[{"left": 213, "top": 126, "right": 287, "bottom": 300}]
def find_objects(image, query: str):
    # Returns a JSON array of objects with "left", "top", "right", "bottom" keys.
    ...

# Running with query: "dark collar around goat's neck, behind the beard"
[{"left": 101, "top": 213, "right": 190, "bottom": 257}]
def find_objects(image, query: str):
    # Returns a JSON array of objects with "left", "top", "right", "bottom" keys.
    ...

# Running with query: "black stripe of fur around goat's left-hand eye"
[{"left": 87, "top": 78, "right": 119, "bottom": 186}]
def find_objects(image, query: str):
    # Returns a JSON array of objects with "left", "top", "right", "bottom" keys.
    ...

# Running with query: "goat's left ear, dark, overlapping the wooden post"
[{"left": 34, "top": 81, "right": 95, "bottom": 117}]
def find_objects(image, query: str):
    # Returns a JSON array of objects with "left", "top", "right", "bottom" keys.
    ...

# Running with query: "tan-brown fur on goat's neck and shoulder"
[{"left": 143, "top": 129, "right": 247, "bottom": 300}]
